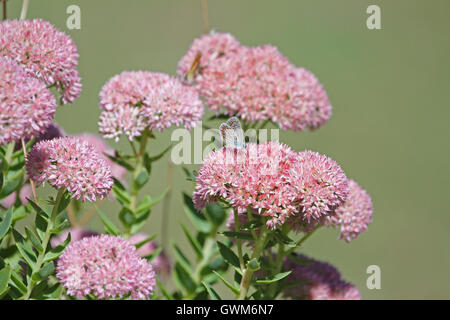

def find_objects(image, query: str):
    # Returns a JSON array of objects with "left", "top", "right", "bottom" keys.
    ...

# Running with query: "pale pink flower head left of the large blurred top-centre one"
[{"left": 99, "top": 71, "right": 203, "bottom": 141}]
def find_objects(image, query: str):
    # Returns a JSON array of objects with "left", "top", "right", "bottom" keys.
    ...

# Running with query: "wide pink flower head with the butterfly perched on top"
[{"left": 193, "top": 142, "right": 348, "bottom": 228}]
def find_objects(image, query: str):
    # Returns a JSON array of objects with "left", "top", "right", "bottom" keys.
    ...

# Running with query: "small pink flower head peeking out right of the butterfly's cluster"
[{"left": 329, "top": 180, "right": 373, "bottom": 242}]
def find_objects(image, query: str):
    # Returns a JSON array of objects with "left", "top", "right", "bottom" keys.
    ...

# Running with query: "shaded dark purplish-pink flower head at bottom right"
[{"left": 283, "top": 254, "right": 361, "bottom": 300}]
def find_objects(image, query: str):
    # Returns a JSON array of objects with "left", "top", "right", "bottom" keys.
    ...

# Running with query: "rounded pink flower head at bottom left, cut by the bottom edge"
[{"left": 56, "top": 235, "right": 155, "bottom": 299}]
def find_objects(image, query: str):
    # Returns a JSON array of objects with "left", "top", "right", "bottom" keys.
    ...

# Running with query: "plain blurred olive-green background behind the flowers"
[{"left": 8, "top": 0, "right": 450, "bottom": 299}]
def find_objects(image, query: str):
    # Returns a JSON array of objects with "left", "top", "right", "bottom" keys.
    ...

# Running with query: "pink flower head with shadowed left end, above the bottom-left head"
[{"left": 27, "top": 137, "right": 113, "bottom": 201}]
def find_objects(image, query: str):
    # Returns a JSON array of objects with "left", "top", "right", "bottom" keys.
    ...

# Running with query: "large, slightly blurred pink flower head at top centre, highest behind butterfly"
[{"left": 178, "top": 33, "right": 331, "bottom": 131}]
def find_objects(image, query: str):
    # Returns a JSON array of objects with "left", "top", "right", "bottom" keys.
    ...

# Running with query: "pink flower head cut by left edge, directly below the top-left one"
[{"left": 0, "top": 56, "right": 56, "bottom": 145}]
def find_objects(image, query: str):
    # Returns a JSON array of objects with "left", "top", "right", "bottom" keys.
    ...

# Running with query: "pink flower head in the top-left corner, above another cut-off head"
[{"left": 0, "top": 19, "right": 81, "bottom": 104}]
